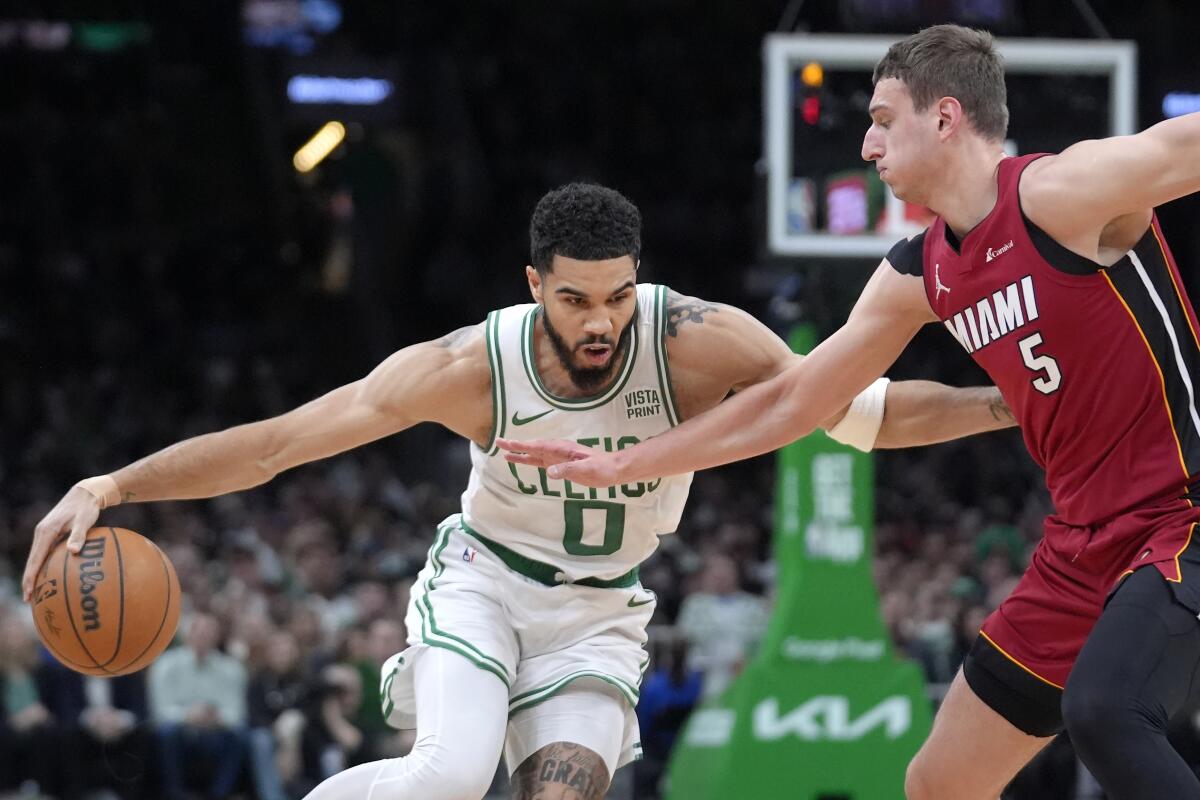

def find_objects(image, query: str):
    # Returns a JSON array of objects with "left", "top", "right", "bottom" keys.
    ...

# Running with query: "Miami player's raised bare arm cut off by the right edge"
[{"left": 1021, "top": 113, "right": 1200, "bottom": 245}]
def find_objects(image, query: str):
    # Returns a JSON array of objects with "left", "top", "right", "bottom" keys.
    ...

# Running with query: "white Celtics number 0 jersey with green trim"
[{"left": 462, "top": 284, "right": 691, "bottom": 581}]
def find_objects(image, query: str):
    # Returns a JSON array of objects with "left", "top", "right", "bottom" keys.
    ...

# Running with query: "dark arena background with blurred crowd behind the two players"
[{"left": 0, "top": 0, "right": 1200, "bottom": 800}]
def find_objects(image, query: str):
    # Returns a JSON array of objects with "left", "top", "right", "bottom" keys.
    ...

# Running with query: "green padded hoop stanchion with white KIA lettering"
[{"left": 666, "top": 327, "right": 932, "bottom": 800}]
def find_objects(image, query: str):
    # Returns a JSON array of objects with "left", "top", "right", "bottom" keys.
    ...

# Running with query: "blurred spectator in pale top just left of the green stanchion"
[{"left": 677, "top": 553, "right": 770, "bottom": 697}]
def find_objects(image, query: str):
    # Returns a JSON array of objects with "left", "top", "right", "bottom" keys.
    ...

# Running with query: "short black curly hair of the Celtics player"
[{"left": 529, "top": 184, "right": 642, "bottom": 275}]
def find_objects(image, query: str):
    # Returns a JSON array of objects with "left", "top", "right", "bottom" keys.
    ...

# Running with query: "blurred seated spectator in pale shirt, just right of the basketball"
[{"left": 150, "top": 613, "right": 247, "bottom": 800}]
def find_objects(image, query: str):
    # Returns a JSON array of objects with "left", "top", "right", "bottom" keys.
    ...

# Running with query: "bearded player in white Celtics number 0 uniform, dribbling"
[{"left": 23, "top": 184, "right": 1012, "bottom": 800}]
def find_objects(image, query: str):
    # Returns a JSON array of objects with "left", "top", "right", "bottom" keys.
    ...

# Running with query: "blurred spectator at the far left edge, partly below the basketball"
[{"left": 0, "top": 613, "right": 64, "bottom": 795}]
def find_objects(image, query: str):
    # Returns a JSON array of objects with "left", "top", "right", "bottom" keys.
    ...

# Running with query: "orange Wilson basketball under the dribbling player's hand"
[{"left": 32, "top": 528, "right": 180, "bottom": 676}]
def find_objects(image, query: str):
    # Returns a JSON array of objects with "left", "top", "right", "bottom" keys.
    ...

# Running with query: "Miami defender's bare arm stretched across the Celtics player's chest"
[{"left": 501, "top": 261, "right": 934, "bottom": 486}]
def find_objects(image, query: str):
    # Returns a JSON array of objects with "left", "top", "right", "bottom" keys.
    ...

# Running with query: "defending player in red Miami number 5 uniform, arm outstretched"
[{"left": 508, "top": 25, "right": 1200, "bottom": 800}]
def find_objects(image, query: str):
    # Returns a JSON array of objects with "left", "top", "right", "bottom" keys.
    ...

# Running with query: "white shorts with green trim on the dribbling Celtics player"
[{"left": 380, "top": 515, "right": 656, "bottom": 775}]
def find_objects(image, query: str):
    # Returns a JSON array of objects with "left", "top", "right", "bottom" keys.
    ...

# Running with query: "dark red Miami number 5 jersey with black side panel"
[{"left": 889, "top": 154, "right": 1200, "bottom": 525}]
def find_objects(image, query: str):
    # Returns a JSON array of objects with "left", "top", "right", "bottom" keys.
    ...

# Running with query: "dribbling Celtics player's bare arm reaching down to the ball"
[{"left": 22, "top": 325, "right": 491, "bottom": 601}]
